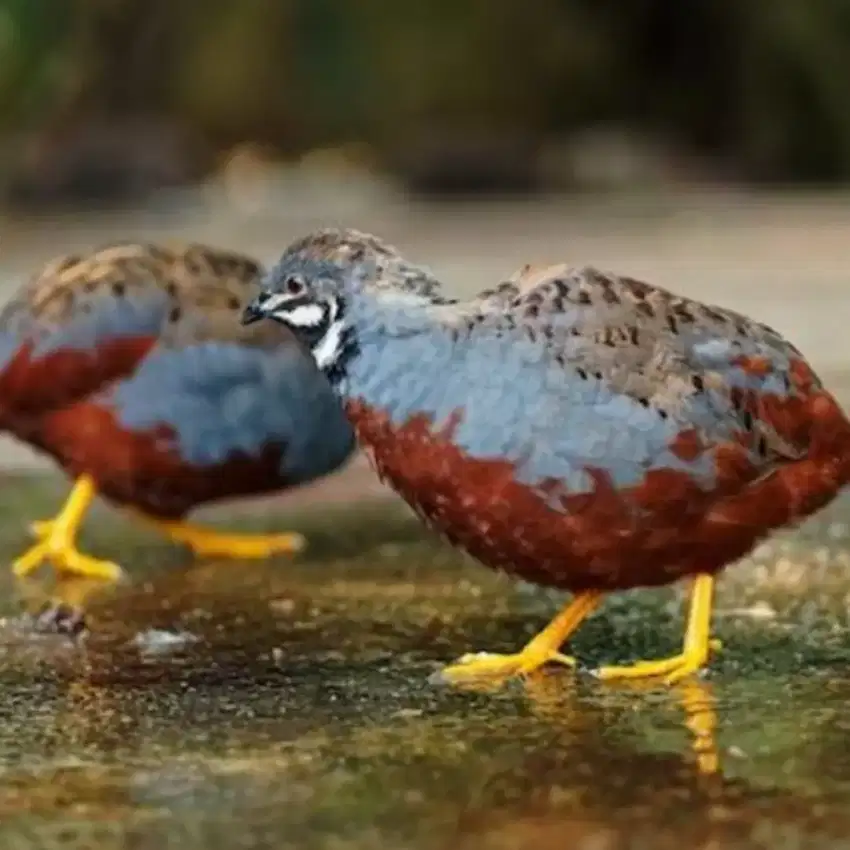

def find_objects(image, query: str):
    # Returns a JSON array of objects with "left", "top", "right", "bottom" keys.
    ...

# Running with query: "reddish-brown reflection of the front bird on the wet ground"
[{"left": 445, "top": 673, "right": 850, "bottom": 850}]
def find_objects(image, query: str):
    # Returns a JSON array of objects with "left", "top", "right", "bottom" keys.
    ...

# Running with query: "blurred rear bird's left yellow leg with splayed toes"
[{"left": 12, "top": 475, "right": 122, "bottom": 581}]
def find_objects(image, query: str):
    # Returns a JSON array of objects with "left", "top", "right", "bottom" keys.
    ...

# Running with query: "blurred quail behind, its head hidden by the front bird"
[{"left": 0, "top": 242, "right": 355, "bottom": 581}]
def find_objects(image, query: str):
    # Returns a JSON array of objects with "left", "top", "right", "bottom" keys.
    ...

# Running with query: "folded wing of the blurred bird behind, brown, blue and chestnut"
[{"left": 0, "top": 243, "right": 260, "bottom": 419}]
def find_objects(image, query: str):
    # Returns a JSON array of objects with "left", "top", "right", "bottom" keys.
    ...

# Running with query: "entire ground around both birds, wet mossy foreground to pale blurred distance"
[{"left": 0, "top": 183, "right": 850, "bottom": 850}]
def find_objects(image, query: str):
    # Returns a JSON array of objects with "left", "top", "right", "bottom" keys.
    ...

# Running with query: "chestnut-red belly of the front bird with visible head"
[{"left": 346, "top": 394, "right": 850, "bottom": 591}]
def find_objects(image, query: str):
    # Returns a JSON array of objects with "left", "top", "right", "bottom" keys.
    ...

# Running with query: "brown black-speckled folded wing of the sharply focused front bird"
[{"left": 496, "top": 266, "right": 820, "bottom": 466}]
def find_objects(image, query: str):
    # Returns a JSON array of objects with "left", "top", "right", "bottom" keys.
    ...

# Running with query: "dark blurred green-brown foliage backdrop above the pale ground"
[{"left": 0, "top": 0, "right": 850, "bottom": 204}]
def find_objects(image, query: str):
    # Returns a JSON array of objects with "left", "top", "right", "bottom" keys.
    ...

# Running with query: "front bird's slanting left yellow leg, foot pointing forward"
[{"left": 436, "top": 591, "right": 603, "bottom": 684}]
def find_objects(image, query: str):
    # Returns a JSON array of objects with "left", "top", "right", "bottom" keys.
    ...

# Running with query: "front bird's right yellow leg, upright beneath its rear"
[{"left": 596, "top": 574, "right": 720, "bottom": 684}]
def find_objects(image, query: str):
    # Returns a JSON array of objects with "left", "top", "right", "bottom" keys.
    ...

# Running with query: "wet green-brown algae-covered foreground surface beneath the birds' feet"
[{"left": 0, "top": 474, "right": 850, "bottom": 850}]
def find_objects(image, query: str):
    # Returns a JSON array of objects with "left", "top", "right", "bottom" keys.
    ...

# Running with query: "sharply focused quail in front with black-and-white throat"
[{"left": 242, "top": 228, "right": 850, "bottom": 685}]
